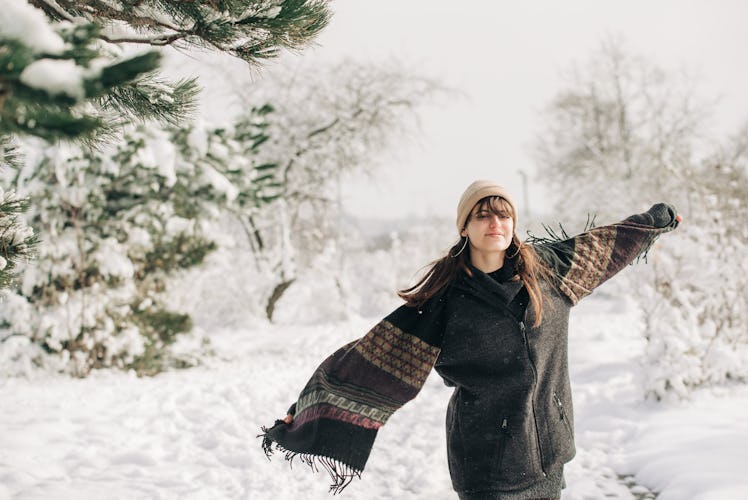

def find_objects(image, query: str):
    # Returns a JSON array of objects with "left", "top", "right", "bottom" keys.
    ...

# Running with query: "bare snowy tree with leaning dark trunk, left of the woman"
[{"left": 231, "top": 61, "right": 447, "bottom": 318}]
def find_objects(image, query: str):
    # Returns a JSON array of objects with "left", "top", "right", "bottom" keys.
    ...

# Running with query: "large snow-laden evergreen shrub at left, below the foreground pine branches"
[{"left": 0, "top": 110, "right": 275, "bottom": 376}]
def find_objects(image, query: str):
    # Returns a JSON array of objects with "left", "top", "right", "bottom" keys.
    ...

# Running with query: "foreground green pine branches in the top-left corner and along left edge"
[{"left": 0, "top": 0, "right": 329, "bottom": 292}]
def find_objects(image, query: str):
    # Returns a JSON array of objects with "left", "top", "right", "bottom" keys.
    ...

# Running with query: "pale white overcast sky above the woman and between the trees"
[{"left": 174, "top": 0, "right": 748, "bottom": 222}]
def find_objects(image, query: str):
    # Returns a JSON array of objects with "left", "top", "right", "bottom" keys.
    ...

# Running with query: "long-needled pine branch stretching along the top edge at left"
[{"left": 30, "top": 0, "right": 330, "bottom": 64}]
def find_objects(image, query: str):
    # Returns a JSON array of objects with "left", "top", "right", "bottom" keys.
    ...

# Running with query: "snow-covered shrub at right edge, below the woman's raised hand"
[{"left": 637, "top": 156, "right": 748, "bottom": 399}]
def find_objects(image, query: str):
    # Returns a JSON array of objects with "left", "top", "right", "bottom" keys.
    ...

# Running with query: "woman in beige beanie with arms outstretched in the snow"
[{"left": 263, "top": 181, "right": 681, "bottom": 500}]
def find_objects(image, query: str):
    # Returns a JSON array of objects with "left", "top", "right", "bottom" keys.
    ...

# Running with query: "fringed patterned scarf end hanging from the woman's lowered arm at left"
[{"left": 261, "top": 292, "right": 444, "bottom": 492}]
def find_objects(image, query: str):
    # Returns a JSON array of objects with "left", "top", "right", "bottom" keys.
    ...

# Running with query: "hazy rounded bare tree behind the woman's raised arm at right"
[{"left": 536, "top": 36, "right": 710, "bottom": 216}]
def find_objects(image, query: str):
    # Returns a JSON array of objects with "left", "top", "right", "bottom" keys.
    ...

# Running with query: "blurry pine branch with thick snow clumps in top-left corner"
[{"left": 0, "top": 0, "right": 159, "bottom": 140}]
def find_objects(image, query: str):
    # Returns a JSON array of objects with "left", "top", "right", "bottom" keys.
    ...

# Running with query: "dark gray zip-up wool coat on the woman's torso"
[{"left": 435, "top": 269, "right": 574, "bottom": 492}]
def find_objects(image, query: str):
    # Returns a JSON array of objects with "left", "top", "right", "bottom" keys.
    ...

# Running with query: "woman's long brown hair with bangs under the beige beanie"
[{"left": 397, "top": 196, "right": 550, "bottom": 326}]
